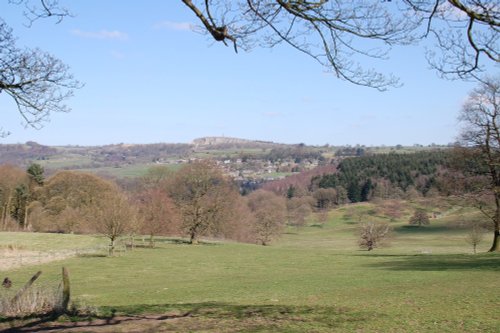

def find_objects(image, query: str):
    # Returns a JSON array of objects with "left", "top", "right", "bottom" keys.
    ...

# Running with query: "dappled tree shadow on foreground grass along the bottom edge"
[{"left": 0, "top": 302, "right": 380, "bottom": 332}]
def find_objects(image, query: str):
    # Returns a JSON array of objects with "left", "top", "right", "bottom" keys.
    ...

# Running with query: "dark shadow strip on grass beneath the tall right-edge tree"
[{"left": 368, "top": 253, "right": 500, "bottom": 272}]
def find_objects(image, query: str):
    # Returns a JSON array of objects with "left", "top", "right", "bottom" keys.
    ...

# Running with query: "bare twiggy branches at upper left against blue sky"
[{"left": 0, "top": 1, "right": 81, "bottom": 136}]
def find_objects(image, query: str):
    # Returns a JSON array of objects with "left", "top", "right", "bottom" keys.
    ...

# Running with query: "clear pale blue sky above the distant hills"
[{"left": 0, "top": 0, "right": 492, "bottom": 146}]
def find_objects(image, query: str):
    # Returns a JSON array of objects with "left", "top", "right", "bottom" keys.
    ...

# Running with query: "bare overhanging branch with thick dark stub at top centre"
[{"left": 182, "top": 0, "right": 415, "bottom": 90}]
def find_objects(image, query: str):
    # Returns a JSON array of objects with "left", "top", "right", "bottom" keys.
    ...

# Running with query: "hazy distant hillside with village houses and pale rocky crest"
[{"left": 0, "top": 137, "right": 450, "bottom": 182}]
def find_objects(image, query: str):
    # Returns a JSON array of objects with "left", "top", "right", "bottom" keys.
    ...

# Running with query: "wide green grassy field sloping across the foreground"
[{"left": 0, "top": 201, "right": 500, "bottom": 332}]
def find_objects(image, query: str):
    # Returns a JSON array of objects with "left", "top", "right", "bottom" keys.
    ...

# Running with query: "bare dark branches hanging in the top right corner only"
[{"left": 404, "top": 0, "right": 500, "bottom": 78}]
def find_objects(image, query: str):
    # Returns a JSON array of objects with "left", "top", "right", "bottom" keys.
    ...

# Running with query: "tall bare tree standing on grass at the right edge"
[{"left": 459, "top": 77, "right": 500, "bottom": 252}]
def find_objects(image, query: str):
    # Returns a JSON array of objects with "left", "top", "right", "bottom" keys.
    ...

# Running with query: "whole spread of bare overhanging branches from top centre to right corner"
[{"left": 182, "top": 0, "right": 500, "bottom": 90}]
